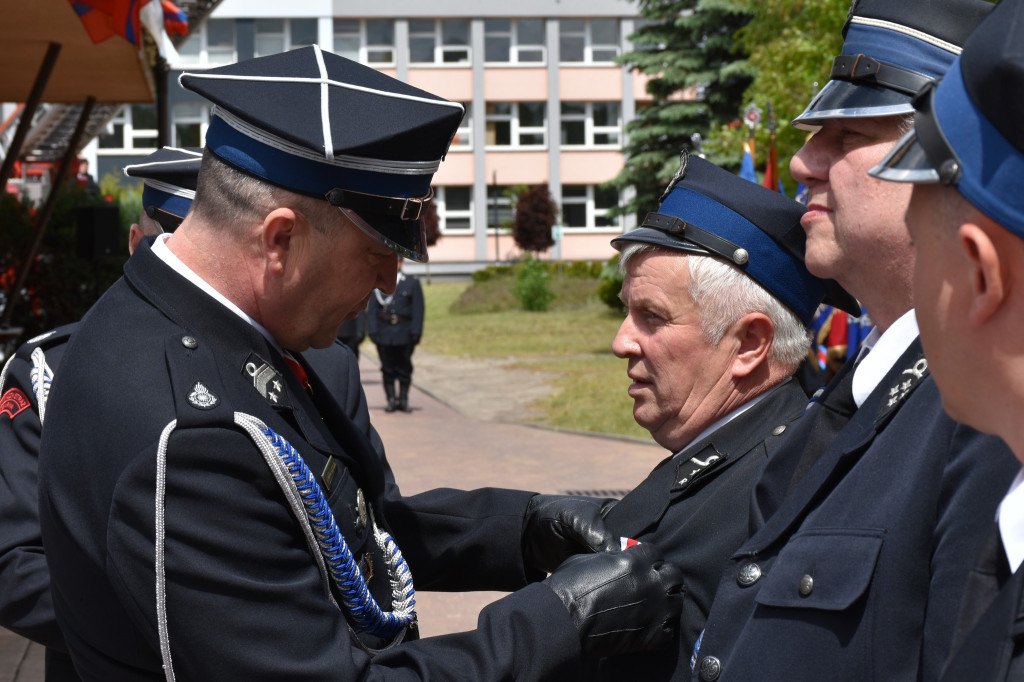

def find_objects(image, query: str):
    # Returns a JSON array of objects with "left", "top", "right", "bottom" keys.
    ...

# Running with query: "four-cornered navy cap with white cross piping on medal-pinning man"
[{"left": 179, "top": 45, "right": 464, "bottom": 261}]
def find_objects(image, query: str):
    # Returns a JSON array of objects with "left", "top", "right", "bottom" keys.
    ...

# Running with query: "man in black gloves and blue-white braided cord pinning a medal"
[{"left": 40, "top": 46, "right": 680, "bottom": 680}]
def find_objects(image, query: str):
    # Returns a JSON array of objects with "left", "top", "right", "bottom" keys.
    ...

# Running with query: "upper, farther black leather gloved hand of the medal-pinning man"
[{"left": 522, "top": 495, "right": 618, "bottom": 573}]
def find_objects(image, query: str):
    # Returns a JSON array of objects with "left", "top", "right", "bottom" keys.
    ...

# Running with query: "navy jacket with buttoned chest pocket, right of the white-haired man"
[{"left": 692, "top": 340, "right": 1019, "bottom": 680}]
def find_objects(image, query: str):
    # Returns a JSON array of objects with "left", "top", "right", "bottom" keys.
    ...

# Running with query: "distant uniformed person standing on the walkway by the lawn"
[{"left": 367, "top": 261, "right": 423, "bottom": 412}]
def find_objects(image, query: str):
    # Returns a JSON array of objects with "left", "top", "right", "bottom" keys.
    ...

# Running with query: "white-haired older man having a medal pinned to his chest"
[{"left": 594, "top": 148, "right": 858, "bottom": 680}]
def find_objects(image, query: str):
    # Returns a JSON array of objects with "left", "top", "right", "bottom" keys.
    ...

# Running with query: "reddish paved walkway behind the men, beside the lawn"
[{"left": 0, "top": 354, "right": 667, "bottom": 682}]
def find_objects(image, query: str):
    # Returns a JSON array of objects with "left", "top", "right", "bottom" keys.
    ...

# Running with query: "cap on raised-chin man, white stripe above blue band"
[{"left": 793, "top": 0, "right": 993, "bottom": 130}]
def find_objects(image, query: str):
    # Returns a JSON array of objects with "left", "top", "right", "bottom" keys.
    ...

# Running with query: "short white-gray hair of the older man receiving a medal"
[{"left": 618, "top": 242, "right": 811, "bottom": 374}]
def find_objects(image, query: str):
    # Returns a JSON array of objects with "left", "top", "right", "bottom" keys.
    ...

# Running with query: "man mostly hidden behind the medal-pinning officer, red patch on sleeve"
[{"left": 0, "top": 147, "right": 202, "bottom": 681}]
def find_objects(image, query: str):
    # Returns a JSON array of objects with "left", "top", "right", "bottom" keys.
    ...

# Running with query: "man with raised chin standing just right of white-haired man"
[{"left": 693, "top": 0, "right": 1019, "bottom": 681}]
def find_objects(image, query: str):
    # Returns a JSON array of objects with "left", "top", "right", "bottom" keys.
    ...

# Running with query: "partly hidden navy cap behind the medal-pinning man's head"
[{"left": 125, "top": 146, "right": 203, "bottom": 231}]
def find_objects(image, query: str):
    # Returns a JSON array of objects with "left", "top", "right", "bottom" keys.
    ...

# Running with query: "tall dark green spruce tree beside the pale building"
[{"left": 610, "top": 0, "right": 753, "bottom": 220}]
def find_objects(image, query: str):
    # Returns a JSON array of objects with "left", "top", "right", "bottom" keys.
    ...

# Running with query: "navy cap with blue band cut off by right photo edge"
[{"left": 869, "top": 0, "right": 1024, "bottom": 237}]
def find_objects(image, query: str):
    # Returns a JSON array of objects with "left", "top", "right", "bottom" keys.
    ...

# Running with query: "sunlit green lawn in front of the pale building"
[{"left": 421, "top": 281, "right": 650, "bottom": 439}]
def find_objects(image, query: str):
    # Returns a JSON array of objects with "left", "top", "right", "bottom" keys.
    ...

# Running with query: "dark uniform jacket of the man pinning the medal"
[{"left": 40, "top": 245, "right": 580, "bottom": 680}]
